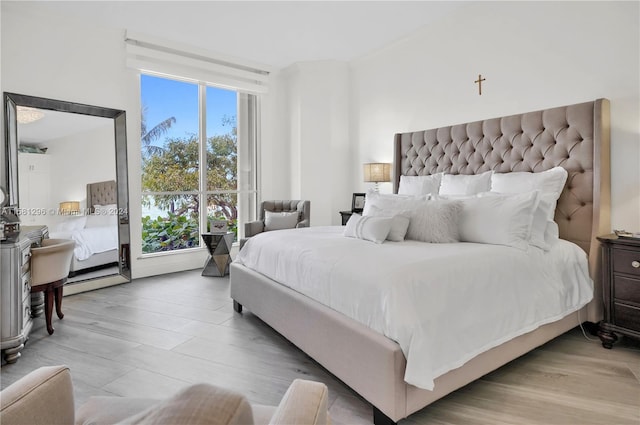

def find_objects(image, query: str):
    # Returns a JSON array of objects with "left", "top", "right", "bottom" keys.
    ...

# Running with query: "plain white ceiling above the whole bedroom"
[{"left": 15, "top": 1, "right": 468, "bottom": 69}]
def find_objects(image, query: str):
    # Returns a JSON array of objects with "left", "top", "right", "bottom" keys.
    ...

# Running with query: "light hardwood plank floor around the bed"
[{"left": 0, "top": 270, "right": 640, "bottom": 425}]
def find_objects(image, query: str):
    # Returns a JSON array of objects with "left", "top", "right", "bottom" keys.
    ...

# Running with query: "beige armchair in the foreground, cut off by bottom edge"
[{"left": 0, "top": 366, "right": 331, "bottom": 425}]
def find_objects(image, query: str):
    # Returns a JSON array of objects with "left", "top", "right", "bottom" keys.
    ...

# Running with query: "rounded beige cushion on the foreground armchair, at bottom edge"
[{"left": 118, "top": 384, "right": 253, "bottom": 425}]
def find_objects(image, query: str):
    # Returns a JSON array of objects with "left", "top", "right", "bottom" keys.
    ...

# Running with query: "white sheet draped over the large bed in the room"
[{"left": 235, "top": 226, "right": 593, "bottom": 390}]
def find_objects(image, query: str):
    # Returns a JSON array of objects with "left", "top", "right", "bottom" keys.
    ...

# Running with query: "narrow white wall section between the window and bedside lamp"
[{"left": 270, "top": 61, "right": 352, "bottom": 226}]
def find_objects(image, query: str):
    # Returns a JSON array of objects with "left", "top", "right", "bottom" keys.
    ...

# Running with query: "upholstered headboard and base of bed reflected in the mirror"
[{"left": 69, "top": 180, "right": 118, "bottom": 277}]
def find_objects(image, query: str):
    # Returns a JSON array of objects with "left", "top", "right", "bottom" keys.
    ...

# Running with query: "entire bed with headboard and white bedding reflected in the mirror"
[{"left": 49, "top": 180, "right": 118, "bottom": 277}]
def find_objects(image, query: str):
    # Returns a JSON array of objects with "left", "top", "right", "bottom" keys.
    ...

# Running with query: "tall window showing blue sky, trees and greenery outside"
[{"left": 141, "top": 74, "right": 257, "bottom": 254}]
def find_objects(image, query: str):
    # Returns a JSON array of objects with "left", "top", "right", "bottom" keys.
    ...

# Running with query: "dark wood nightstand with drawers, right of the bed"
[{"left": 598, "top": 235, "right": 640, "bottom": 348}]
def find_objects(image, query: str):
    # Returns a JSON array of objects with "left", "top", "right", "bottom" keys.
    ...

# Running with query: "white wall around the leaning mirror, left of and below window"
[{"left": 0, "top": 2, "right": 207, "bottom": 278}]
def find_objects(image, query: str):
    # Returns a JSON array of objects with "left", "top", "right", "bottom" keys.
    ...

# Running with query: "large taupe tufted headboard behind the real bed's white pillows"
[{"left": 393, "top": 99, "right": 611, "bottom": 322}]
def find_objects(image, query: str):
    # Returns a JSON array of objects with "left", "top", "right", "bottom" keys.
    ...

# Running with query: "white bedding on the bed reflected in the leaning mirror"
[{"left": 49, "top": 226, "right": 118, "bottom": 261}]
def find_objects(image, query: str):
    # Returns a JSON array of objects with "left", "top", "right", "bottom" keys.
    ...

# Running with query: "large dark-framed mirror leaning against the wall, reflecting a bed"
[{"left": 3, "top": 93, "right": 131, "bottom": 294}]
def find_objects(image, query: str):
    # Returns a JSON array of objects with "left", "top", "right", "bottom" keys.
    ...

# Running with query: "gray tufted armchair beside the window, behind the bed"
[{"left": 240, "top": 200, "right": 311, "bottom": 249}]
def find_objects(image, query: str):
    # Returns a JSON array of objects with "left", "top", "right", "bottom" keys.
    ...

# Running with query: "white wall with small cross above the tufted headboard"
[{"left": 351, "top": 2, "right": 640, "bottom": 230}]
